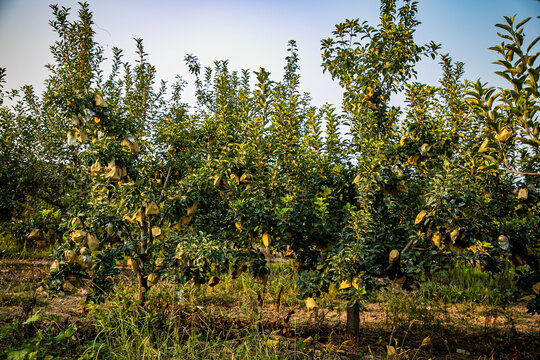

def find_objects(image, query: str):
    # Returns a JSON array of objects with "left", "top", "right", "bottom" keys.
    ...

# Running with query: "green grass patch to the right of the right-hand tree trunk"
[{"left": 374, "top": 264, "right": 516, "bottom": 338}]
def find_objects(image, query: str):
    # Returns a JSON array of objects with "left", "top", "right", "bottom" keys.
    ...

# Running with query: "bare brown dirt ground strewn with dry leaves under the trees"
[{"left": 0, "top": 260, "right": 540, "bottom": 360}]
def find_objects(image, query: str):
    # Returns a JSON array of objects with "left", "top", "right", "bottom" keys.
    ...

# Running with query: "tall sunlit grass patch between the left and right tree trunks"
[{"left": 82, "top": 262, "right": 352, "bottom": 359}]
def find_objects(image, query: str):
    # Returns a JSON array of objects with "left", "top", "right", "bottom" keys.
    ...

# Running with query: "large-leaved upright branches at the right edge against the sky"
[{"left": 469, "top": 16, "right": 540, "bottom": 176}]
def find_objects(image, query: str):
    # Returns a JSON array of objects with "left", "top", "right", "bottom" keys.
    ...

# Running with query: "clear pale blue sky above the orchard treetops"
[{"left": 0, "top": 0, "right": 540, "bottom": 106}]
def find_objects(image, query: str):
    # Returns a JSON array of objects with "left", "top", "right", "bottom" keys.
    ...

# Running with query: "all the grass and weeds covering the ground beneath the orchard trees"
[{"left": 0, "top": 255, "right": 532, "bottom": 360}]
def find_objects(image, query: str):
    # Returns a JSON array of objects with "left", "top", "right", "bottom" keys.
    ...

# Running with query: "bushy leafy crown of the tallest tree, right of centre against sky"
[{"left": 321, "top": 1, "right": 438, "bottom": 151}]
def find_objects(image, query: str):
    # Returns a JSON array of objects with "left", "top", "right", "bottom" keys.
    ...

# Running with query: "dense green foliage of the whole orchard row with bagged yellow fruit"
[{"left": 0, "top": 0, "right": 540, "bottom": 312}]
